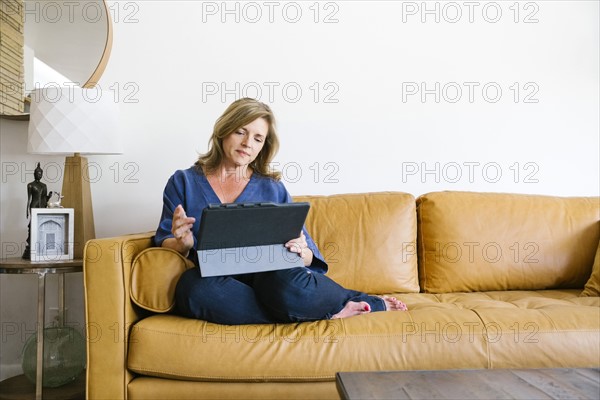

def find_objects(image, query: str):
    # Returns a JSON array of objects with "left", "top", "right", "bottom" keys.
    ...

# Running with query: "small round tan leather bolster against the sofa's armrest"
[{"left": 131, "top": 247, "right": 194, "bottom": 313}]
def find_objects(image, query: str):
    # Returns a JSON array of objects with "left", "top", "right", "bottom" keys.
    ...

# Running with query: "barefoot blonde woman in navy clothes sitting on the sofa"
[{"left": 154, "top": 98, "right": 406, "bottom": 325}]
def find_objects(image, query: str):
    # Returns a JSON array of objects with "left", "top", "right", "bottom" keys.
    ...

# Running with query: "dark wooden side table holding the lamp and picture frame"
[{"left": 0, "top": 258, "right": 85, "bottom": 400}]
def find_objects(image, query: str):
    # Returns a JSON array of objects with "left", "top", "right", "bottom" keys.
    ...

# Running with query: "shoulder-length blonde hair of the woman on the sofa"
[{"left": 194, "top": 97, "right": 281, "bottom": 180}]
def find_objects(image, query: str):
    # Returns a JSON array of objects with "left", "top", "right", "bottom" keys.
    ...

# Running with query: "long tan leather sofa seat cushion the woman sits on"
[{"left": 128, "top": 290, "right": 600, "bottom": 382}]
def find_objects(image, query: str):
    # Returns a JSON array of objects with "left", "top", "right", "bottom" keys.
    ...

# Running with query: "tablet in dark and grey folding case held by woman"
[{"left": 197, "top": 202, "right": 310, "bottom": 276}]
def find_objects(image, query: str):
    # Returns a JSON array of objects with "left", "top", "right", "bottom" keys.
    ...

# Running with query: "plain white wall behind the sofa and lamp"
[{"left": 0, "top": 1, "right": 600, "bottom": 378}]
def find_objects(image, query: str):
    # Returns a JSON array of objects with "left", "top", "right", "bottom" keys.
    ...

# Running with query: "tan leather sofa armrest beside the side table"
[{"left": 83, "top": 232, "right": 154, "bottom": 399}]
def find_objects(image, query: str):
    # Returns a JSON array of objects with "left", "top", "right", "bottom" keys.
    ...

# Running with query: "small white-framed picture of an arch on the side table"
[{"left": 30, "top": 208, "right": 74, "bottom": 261}]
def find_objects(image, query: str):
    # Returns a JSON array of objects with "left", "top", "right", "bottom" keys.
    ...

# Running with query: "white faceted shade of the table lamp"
[{"left": 27, "top": 86, "right": 123, "bottom": 154}]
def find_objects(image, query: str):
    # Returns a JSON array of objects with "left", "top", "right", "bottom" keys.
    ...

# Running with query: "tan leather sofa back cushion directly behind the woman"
[{"left": 294, "top": 192, "right": 419, "bottom": 294}]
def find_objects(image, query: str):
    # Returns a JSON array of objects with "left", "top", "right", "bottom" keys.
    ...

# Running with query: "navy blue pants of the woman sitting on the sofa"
[{"left": 175, "top": 267, "right": 386, "bottom": 325}]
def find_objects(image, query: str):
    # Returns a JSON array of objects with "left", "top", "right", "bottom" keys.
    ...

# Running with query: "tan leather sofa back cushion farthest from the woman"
[{"left": 417, "top": 192, "right": 600, "bottom": 293}]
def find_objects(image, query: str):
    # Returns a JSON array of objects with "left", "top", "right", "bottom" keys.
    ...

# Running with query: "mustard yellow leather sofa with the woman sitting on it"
[{"left": 84, "top": 192, "right": 600, "bottom": 399}]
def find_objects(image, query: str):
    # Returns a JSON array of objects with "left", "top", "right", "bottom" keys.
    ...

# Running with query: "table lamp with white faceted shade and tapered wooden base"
[{"left": 27, "top": 86, "right": 122, "bottom": 258}]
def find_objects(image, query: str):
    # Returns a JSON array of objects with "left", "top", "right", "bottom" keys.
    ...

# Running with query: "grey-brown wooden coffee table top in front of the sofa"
[{"left": 336, "top": 368, "right": 600, "bottom": 400}]
